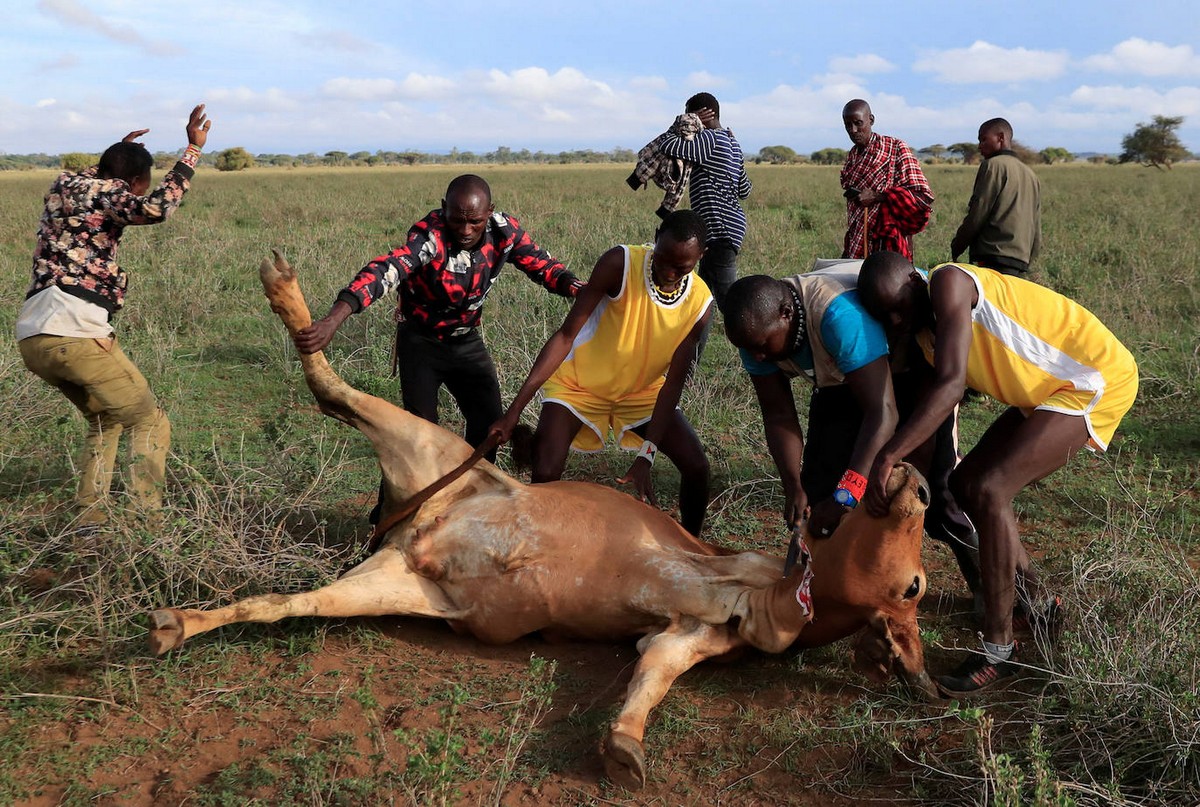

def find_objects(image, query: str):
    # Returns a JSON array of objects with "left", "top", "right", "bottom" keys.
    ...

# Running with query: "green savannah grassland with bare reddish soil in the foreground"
[{"left": 0, "top": 160, "right": 1200, "bottom": 805}]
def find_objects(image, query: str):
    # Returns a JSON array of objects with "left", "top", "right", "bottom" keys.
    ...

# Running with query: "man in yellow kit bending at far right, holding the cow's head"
[{"left": 858, "top": 252, "right": 1138, "bottom": 697}]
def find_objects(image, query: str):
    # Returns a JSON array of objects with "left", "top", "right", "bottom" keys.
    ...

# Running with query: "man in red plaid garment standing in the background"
[{"left": 841, "top": 98, "right": 934, "bottom": 261}]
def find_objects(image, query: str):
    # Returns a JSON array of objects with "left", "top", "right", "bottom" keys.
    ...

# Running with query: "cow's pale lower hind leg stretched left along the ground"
[{"left": 149, "top": 548, "right": 466, "bottom": 654}]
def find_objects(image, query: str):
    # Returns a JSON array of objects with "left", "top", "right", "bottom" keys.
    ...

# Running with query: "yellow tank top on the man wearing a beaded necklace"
[{"left": 547, "top": 244, "right": 713, "bottom": 401}]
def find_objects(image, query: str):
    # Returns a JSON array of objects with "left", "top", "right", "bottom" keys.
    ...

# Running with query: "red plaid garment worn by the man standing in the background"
[{"left": 841, "top": 133, "right": 934, "bottom": 261}]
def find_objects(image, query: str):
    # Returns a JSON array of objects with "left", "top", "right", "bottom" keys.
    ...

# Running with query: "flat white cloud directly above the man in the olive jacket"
[{"left": 913, "top": 40, "right": 1068, "bottom": 84}]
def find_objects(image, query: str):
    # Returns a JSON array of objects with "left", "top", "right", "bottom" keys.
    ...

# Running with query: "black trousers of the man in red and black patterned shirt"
[{"left": 396, "top": 322, "right": 504, "bottom": 461}]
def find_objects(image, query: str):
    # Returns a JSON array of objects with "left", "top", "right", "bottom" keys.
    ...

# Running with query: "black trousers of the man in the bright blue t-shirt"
[{"left": 800, "top": 372, "right": 979, "bottom": 591}]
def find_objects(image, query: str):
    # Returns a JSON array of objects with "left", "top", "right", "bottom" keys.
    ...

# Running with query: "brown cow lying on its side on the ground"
[{"left": 150, "top": 253, "right": 936, "bottom": 788}]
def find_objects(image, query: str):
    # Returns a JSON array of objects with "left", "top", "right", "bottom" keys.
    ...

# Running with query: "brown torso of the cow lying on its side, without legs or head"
[{"left": 409, "top": 484, "right": 732, "bottom": 642}]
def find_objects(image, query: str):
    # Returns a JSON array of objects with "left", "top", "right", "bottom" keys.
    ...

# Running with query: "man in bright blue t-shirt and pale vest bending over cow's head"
[{"left": 725, "top": 261, "right": 979, "bottom": 592}]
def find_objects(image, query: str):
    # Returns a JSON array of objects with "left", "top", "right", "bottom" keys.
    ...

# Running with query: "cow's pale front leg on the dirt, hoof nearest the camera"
[{"left": 601, "top": 617, "right": 745, "bottom": 790}]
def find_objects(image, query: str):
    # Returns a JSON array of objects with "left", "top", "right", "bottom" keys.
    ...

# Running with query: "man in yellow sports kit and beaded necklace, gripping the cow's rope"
[{"left": 491, "top": 210, "right": 713, "bottom": 536}]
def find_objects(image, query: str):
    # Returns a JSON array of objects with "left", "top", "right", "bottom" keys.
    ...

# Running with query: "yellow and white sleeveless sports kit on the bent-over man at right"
[{"left": 918, "top": 263, "right": 1138, "bottom": 411}]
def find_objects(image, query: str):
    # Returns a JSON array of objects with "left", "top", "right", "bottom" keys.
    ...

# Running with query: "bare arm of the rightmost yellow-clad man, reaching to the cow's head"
[{"left": 865, "top": 267, "right": 978, "bottom": 516}]
